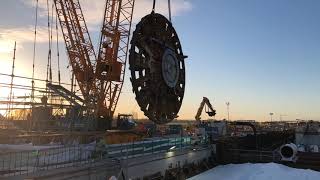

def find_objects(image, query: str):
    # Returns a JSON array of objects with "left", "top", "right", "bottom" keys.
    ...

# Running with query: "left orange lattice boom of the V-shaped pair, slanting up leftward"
[{"left": 54, "top": 0, "right": 96, "bottom": 101}]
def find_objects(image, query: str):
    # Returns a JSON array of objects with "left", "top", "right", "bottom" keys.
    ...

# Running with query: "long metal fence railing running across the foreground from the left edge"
[{"left": 0, "top": 137, "right": 207, "bottom": 177}]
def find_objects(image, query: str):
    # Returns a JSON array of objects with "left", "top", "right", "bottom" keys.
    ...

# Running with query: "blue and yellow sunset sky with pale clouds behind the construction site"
[{"left": 0, "top": 0, "right": 320, "bottom": 121}]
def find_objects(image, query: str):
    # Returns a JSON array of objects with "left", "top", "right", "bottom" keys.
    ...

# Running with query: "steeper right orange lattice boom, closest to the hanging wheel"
[{"left": 96, "top": 0, "right": 135, "bottom": 117}]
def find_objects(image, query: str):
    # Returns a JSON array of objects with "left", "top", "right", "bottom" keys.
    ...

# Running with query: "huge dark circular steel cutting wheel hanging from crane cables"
[{"left": 129, "top": 13, "right": 185, "bottom": 124}]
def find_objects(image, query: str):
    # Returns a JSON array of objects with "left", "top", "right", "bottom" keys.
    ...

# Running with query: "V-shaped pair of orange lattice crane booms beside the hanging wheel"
[{"left": 54, "top": 0, "right": 135, "bottom": 126}]
